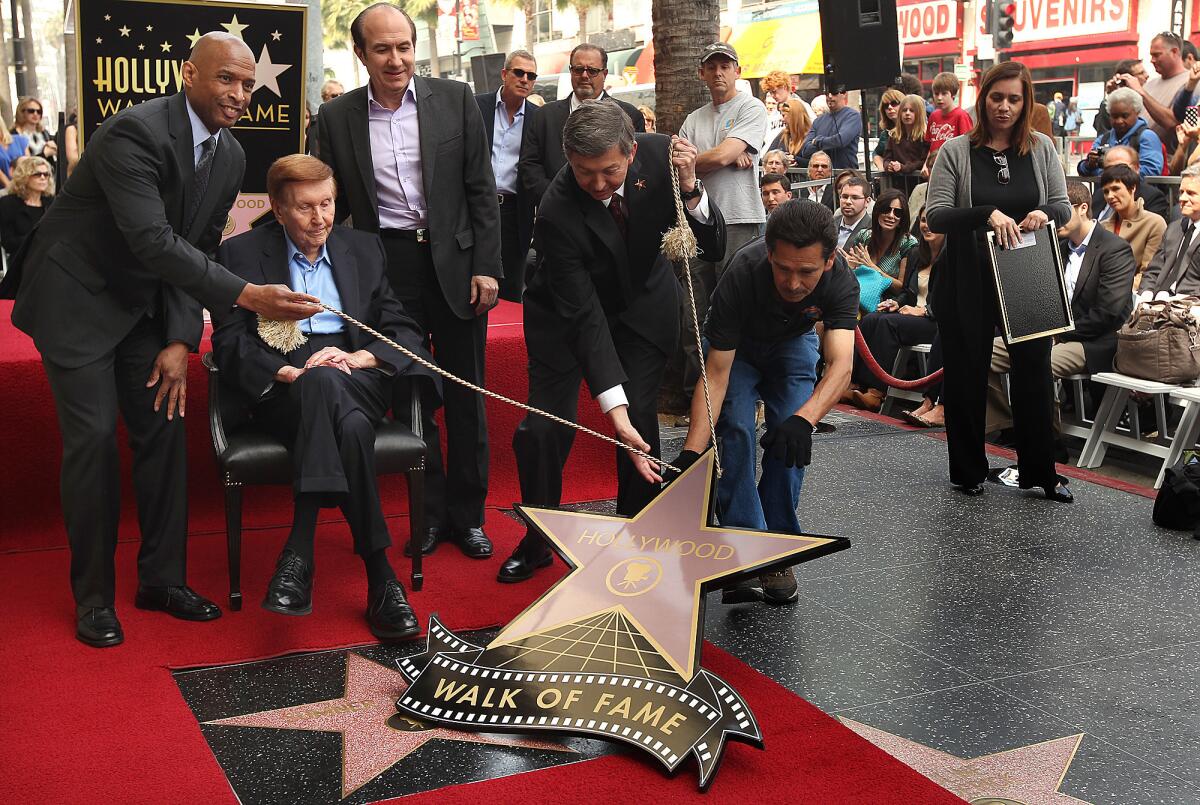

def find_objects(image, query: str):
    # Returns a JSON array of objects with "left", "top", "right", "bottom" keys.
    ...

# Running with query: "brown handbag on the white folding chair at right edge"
[{"left": 1114, "top": 296, "right": 1200, "bottom": 384}]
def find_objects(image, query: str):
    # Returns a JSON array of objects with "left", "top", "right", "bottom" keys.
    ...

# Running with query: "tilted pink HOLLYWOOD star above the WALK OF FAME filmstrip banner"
[{"left": 490, "top": 451, "right": 848, "bottom": 680}]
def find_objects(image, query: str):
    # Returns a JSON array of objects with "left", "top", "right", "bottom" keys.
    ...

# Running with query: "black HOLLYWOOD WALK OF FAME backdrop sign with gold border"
[{"left": 76, "top": 0, "right": 308, "bottom": 193}]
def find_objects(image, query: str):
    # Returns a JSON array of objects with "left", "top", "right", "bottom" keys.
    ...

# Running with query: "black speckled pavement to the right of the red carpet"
[{"left": 664, "top": 413, "right": 1200, "bottom": 804}]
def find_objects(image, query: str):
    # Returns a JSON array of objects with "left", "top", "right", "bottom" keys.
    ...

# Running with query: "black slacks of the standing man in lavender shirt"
[{"left": 383, "top": 236, "right": 488, "bottom": 529}]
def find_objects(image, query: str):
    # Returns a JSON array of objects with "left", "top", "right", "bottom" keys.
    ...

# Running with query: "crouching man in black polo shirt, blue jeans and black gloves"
[{"left": 673, "top": 200, "right": 858, "bottom": 603}]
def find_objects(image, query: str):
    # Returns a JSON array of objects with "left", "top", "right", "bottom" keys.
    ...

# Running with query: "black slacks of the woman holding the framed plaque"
[{"left": 937, "top": 283, "right": 1057, "bottom": 488}]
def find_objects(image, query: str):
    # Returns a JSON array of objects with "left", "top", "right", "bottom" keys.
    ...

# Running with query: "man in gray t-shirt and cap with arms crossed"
[{"left": 664, "top": 42, "right": 767, "bottom": 413}]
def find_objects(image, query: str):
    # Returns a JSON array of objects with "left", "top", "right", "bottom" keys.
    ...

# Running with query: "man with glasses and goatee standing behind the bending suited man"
[{"left": 518, "top": 44, "right": 646, "bottom": 204}]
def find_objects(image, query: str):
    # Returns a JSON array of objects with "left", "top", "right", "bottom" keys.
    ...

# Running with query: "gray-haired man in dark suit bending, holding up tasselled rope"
[{"left": 498, "top": 101, "right": 725, "bottom": 582}]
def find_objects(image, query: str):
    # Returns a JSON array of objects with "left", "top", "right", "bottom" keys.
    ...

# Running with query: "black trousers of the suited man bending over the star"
[{"left": 512, "top": 321, "right": 667, "bottom": 516}]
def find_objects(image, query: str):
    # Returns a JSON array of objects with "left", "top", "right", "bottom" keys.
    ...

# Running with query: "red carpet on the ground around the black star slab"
[{"left": 0, "top": 512, "right": 960, "bottom": 805}]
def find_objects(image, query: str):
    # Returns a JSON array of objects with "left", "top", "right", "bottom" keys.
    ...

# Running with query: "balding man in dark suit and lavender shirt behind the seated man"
[{"left": 317, "top": 2, "right": 503, "bottom": 559}]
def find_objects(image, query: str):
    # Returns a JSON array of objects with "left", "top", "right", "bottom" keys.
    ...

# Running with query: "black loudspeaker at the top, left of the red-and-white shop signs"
[{"left": 818, "top": 0, "right": 900, "bottom": 92}]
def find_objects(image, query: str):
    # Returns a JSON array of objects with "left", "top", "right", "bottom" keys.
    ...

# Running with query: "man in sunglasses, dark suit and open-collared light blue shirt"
[{"left": 475, "top": 50, "right": 541, "bottom": 302}]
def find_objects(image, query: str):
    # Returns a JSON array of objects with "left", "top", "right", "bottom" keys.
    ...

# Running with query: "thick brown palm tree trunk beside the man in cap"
[{"left": 650, "top": 0, "right": 720, "bottom": 134}]
